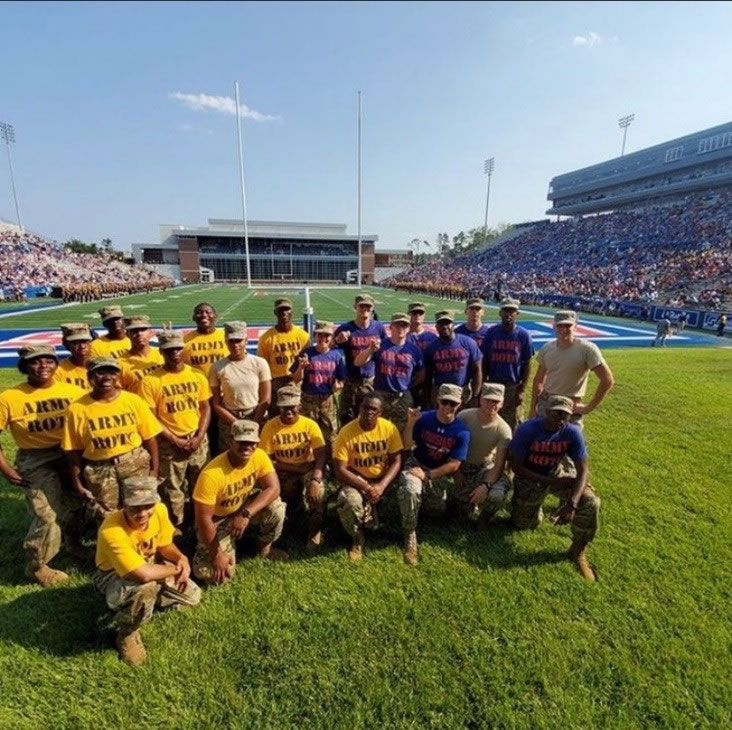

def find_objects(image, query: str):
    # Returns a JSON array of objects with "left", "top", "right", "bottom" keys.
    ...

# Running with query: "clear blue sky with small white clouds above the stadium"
[{"left": 0, "top": 2, "right": 732, "bottom": 248}]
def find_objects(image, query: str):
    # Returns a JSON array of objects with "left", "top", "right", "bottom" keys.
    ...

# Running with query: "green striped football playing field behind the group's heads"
[{"left": 0, "top": 284, "right": 596, "bottom": 329}]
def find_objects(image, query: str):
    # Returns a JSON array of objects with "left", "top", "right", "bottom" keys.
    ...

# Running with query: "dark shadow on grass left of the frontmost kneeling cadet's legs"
[{"left": 0, "top": 584, "right": 108, "bottom": 657}]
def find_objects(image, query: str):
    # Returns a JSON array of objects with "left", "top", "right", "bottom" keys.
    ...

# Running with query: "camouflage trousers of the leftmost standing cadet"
[{"left": 16, "top": 446, "right": 84, "bottom": 572}]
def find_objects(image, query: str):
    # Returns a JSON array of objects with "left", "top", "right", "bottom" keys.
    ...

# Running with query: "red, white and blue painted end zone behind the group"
[{"left": 0, "top": 317, "right": 732, "bottom": 367}]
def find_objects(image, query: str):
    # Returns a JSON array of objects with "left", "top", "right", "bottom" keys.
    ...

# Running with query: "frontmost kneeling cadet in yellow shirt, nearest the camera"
[{"left": 94, "top": 477, "right": 201, "bottom": 666}]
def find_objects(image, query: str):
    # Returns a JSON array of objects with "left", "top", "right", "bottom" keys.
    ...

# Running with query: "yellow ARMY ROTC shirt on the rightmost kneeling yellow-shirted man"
[{"left": 333, "top": 418, "right": 404, "bottom": 479}]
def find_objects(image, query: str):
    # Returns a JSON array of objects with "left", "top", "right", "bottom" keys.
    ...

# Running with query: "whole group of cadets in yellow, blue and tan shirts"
[{"left": 0, "top": 295, "right": 613, "bottom": 664}]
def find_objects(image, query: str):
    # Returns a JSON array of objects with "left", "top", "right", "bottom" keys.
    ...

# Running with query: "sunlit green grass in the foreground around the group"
[{"left": 0, "top": 346, "right": 732, "bottom": 728}]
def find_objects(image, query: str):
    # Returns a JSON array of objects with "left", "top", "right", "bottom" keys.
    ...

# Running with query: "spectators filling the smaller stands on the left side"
[{"left": 0, "top": 231, "right": 173, "bottom": 301}]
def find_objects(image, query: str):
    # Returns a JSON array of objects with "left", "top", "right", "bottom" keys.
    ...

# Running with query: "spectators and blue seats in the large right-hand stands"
[{"left": 385, "top": 191, "right": 732, "bottom": 309}]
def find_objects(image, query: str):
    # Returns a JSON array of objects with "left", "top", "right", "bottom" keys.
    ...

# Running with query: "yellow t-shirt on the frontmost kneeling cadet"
[{"left": 96, "top": 502, "right": 174, "bottom": 578}]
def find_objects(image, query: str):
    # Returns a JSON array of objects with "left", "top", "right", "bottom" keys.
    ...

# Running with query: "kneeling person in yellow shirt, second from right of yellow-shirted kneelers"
[{"left": 261, "top": 383, "right": 325, "bottom": 552}]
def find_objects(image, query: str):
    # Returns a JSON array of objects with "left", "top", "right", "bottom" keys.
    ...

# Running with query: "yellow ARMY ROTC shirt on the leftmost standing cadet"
[{"left": 0, "top": 383, "right": 84, "bottom": 449}]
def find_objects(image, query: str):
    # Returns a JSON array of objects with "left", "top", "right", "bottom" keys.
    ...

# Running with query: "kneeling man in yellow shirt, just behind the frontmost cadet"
[{"left": 193, "top": 419, "right": 288, "bottom": 584}]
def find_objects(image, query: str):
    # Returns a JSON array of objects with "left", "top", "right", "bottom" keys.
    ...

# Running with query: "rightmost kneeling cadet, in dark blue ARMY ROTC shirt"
[{"left": 510, "top": 395, "right": 600, "bottom": 582}]
